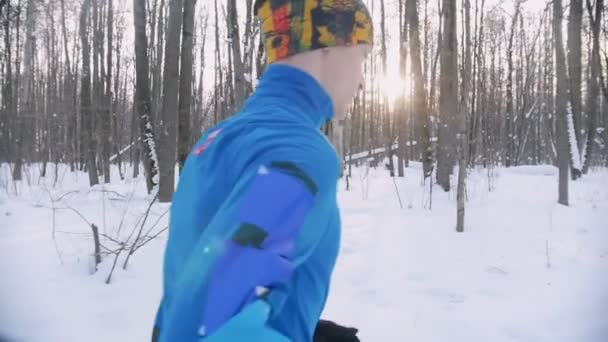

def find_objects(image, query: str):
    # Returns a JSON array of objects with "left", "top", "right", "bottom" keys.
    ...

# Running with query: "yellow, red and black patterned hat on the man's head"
[{"left": 255, "top": 0, "right": 374, "bottom": 64}]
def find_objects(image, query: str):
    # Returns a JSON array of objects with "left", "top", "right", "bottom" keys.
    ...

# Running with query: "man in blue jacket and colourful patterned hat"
[{"left": 153, "top": 0, "right": 373, "bottom": 342}]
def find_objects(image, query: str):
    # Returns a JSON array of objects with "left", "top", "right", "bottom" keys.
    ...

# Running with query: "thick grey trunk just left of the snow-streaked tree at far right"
[{"left": 553, "top": 0, "right": 570, "bottom": 205}]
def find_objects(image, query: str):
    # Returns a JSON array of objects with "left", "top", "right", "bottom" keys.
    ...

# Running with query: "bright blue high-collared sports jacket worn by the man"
[{"left": 155, "top": 65, "right": 340, "bottom": 342}]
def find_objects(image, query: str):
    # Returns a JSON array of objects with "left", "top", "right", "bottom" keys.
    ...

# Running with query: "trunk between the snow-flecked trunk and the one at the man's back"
[{"left": 158, "top": 0, "right": 183, "bottom": 203}]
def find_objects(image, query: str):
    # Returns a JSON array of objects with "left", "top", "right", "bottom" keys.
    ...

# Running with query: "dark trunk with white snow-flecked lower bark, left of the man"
[{"left": 133, "top": 0, "right": 159, "bottom": 193}]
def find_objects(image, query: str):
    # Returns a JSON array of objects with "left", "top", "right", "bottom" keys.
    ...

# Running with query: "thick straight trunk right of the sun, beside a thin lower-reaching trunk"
[{"left": 437, "top": 0, "right": 458, "bottom": 192}]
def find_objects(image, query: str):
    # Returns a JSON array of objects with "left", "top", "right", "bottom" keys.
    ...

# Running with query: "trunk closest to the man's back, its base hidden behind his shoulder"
[{"left": 177, "top": 0, "right": 196, "bottom": 171}]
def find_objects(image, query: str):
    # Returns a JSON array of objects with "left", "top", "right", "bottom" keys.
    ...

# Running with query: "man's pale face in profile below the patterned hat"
[{"left": 323, "top": 44, "right": 372, "bottom": 120}]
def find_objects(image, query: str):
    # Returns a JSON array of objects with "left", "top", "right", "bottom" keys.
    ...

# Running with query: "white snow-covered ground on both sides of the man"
[{"left": 0, "top": 164, "right": 608, "bottom": 342}]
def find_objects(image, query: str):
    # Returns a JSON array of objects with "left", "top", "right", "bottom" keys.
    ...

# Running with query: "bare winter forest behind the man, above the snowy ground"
[{"left": 0, "top": 0, "right": 608, "bottom": 222}]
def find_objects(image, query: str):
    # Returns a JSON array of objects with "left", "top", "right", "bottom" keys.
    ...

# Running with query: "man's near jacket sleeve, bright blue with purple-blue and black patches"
[{"left": 159, "top": 150, "right": 337, "bottom": 341}]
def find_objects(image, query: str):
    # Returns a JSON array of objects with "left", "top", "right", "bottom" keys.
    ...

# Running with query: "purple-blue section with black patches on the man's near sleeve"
[{"left": 202, "top": 162, "right": 322, "bottom": 335}]
